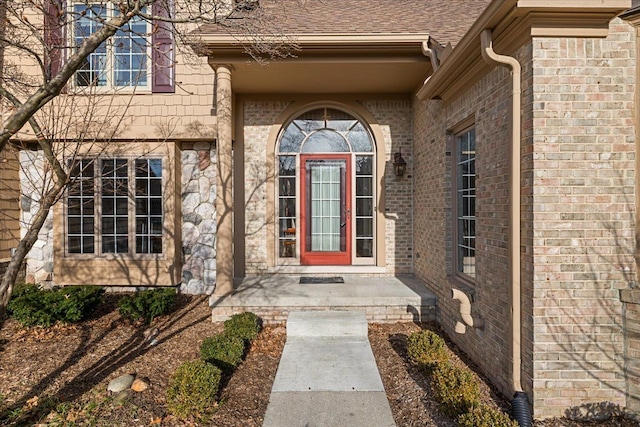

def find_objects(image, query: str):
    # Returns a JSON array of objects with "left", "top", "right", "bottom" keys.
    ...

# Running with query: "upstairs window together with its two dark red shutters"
[{"left": 43, "top": 0, "right": 175, "bottom": 93}]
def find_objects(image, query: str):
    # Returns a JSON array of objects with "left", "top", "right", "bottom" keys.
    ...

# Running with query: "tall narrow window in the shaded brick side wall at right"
[{"left": 453, "top": 128, "right": 476, "bottom": 279}]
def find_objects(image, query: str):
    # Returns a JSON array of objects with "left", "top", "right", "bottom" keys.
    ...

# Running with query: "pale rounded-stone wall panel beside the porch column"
[{"left": 180, "top": 142, "right": 216, "bottom": 294}]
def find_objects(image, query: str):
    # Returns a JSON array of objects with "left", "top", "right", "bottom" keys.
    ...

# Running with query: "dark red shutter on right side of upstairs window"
[{"left": 151, "top": 0, "right": 175, "bottom": 93}]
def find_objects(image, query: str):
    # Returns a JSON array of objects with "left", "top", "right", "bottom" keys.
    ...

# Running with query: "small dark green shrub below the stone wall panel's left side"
[{"left": 118, "top": 288, "right": 176, "bottom": 323}]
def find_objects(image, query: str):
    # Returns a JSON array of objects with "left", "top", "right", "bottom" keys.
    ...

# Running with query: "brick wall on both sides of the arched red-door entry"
[{"left": 244, "top": 100, "right": 413, "bottom": 276}]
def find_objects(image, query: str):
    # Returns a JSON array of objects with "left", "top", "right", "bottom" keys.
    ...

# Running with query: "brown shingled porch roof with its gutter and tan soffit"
[{"left": 194, "top": 0, "right": 490, "bottom": 94}]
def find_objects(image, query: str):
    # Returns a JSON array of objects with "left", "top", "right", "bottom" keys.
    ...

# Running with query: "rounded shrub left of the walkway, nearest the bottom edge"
[{"left": 167, "top": 360, "right": 222, "bottom": 418}]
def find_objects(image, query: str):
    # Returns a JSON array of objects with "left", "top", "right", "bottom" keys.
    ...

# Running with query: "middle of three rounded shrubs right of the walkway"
[{"left": 431, "top": 363, "right": 480, "bottom": 418}]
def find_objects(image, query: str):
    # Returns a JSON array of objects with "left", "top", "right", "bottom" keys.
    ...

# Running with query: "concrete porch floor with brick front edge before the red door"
[{"left": 209, "top": 274, "right": 436, "bottom": 323}]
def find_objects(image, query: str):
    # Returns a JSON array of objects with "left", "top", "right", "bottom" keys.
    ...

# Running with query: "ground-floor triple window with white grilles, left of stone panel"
[{"left": 66, "top": 158, "right": 164, "bottom": 255}]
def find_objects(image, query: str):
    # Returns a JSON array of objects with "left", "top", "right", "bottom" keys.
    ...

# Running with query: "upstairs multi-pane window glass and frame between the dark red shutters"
[{"left": 71, "top": 2, "right": 152, "bottom": 90}]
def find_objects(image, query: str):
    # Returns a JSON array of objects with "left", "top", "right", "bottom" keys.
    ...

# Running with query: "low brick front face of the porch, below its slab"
[{"left": 212, "top": 305, "right": 435, "bottom": 324}]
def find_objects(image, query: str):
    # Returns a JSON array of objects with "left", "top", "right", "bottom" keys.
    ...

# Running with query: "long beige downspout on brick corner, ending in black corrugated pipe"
[{"left": 480, "top": 29, "right": 533, "bottom": 426}]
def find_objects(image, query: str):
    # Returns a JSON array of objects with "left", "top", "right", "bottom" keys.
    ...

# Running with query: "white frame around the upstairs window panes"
[{"left": 67, "top": 1, "right": 153, "bottom": 93}]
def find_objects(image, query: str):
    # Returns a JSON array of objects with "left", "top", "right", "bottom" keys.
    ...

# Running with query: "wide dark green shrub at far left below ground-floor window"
[{"left": 8, "top": 285, "right": 104, "bottom": 327}]
